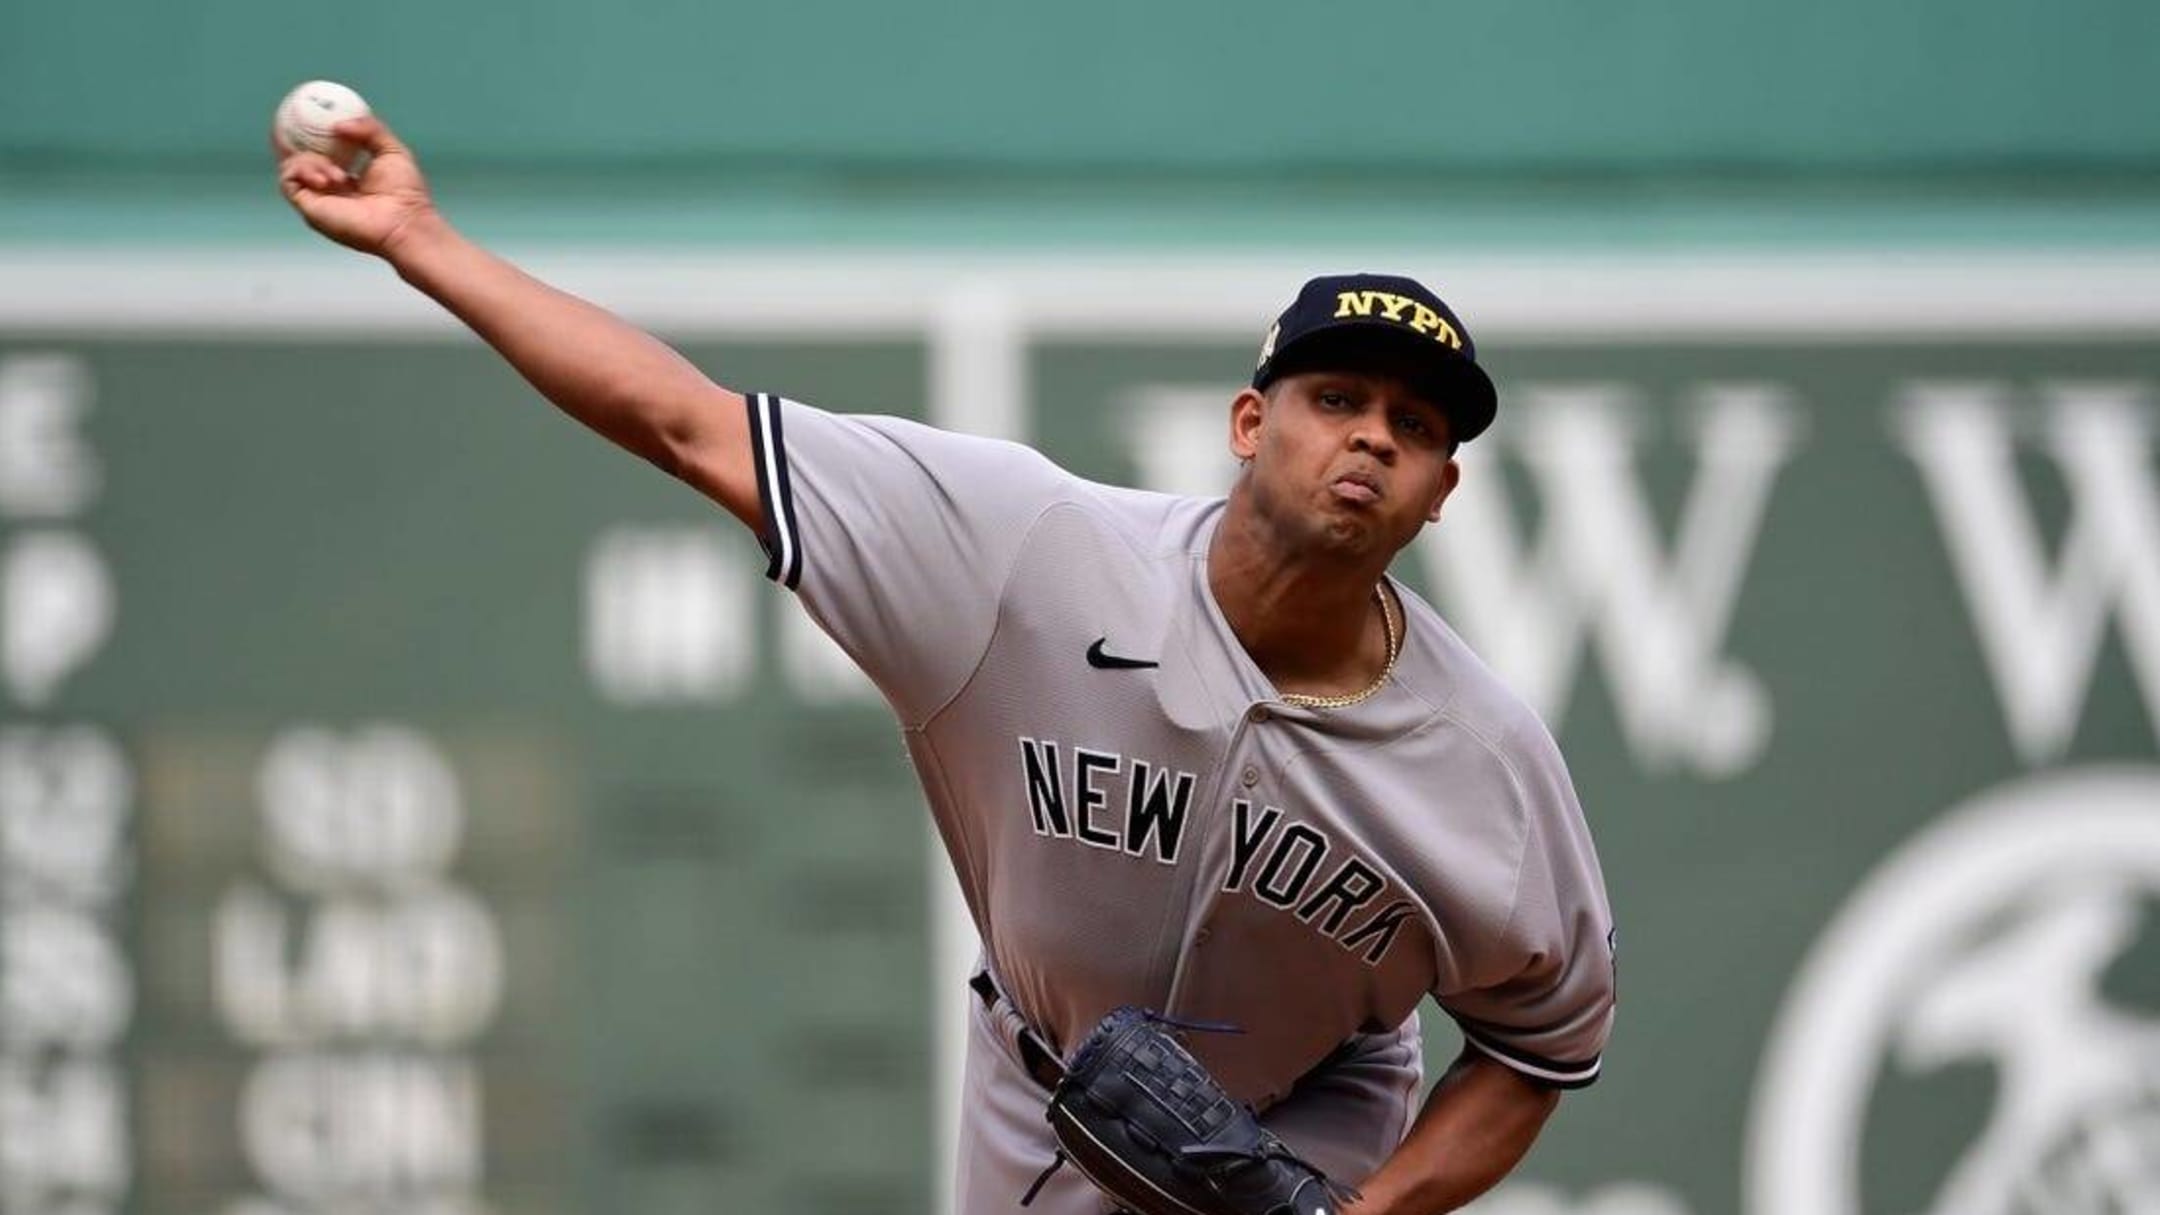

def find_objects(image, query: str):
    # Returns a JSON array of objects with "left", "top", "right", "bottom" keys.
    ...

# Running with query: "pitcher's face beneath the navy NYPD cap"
[{"left": 1231, "top": 372, "right": 1460, "bottom": 556}]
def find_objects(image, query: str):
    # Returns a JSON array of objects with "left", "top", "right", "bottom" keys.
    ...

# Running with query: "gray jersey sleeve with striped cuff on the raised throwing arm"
[{"left": 745, "top": 393, "right": 1071, "bottom": 724}]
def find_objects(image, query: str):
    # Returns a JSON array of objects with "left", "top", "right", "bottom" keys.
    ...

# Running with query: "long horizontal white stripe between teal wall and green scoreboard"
[{"left": 0, "top": 244, "right": 2160, "bottom": 342}]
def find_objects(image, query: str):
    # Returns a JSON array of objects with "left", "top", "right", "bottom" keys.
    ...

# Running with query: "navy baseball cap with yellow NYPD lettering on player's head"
[{"left": 1253, "top": 275, "right": 1499, "bottom": 443}]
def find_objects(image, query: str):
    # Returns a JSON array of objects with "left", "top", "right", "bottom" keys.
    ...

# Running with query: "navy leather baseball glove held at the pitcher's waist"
[{"left": 1020, "top": 1007, "right": 1356, "bottom": 1215}]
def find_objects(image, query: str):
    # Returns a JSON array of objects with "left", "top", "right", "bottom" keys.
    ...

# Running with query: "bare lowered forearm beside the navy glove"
[{"left": 1346, "top": 1051, "right": 1560, "bottom": 1215}]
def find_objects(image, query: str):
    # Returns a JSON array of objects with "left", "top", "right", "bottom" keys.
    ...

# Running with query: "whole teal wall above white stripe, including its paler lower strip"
[{"left": 0, "top": 0, "right": 2160, "bottom": 246}]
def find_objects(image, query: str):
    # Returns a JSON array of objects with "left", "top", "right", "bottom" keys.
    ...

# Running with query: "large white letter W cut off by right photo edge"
[{"left": 1894, "top": 383, "right": 2160, "bottom": 763}]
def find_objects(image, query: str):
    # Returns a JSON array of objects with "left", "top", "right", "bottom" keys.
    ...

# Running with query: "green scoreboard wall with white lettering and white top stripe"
[{"left": 0, "top": 255, "right": 2160, "bottom": 1215}]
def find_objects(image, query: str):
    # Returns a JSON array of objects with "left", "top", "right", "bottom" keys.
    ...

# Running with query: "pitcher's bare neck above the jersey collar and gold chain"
[{"left": 1207, "top": 484, "right": 1387, "bottom": 696}]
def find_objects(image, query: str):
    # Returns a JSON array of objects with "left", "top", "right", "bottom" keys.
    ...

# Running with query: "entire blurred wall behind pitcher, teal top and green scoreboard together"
[{"left": 0, "top": 0, "right": 2160, "bottom": 1215}]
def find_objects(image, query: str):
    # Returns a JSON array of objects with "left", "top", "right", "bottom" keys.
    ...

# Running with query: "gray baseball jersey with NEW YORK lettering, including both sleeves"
[{"left": 750, "top": 396, "right": 1614, "bottom": 1193}]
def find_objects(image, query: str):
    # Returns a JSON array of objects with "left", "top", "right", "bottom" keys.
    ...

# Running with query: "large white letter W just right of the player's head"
[{"left": 1419, "top": 383, "right": 1801, "bottom": 776}]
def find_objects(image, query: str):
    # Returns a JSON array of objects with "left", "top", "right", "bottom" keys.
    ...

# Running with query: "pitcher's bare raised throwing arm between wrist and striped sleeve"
[{"left": 384, "top": 214, "right": 758, "bottom": 528}]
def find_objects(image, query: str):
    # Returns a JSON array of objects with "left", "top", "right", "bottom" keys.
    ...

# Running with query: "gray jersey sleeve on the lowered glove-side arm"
[{"left": 1439, "top": 713, "right": 1618, "bottom": 1087}]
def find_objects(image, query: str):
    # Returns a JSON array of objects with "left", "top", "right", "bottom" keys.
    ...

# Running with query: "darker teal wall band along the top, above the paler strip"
[{"left": 12, "top": 0, "right": 2160, "bottom": 173}]
